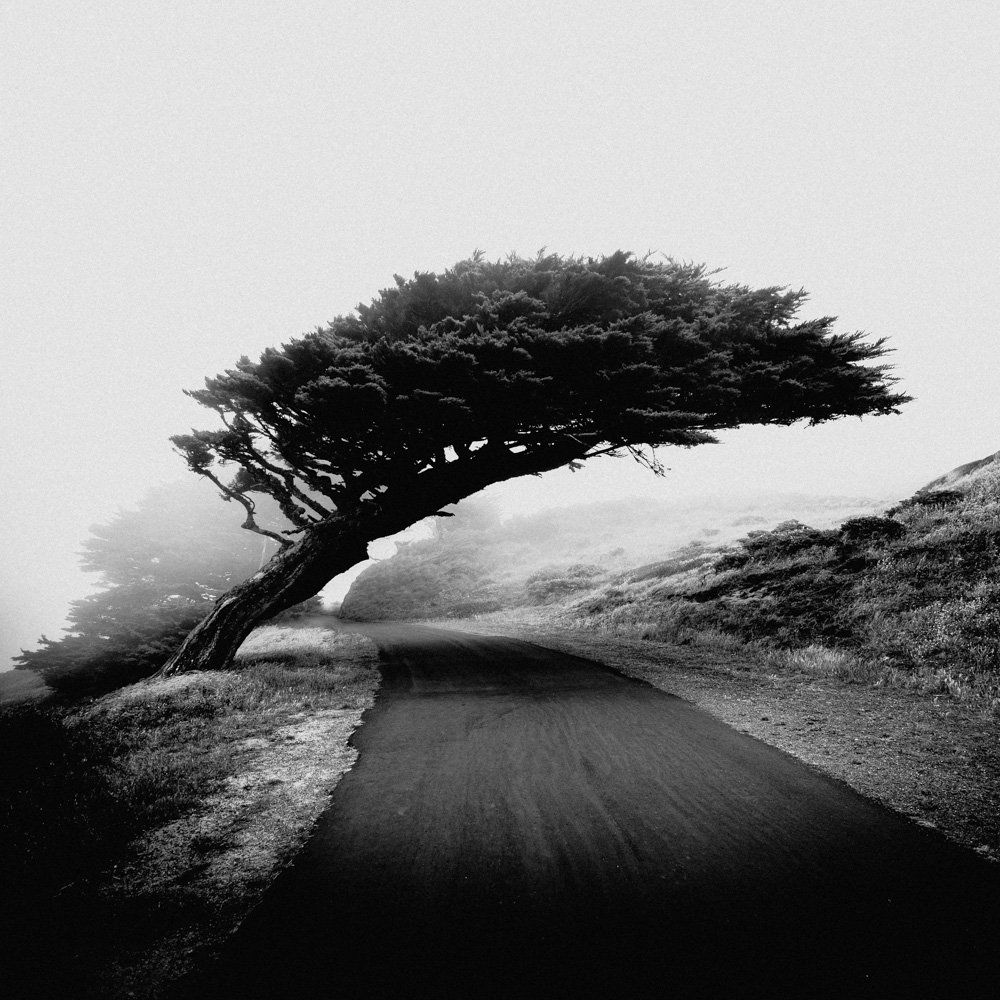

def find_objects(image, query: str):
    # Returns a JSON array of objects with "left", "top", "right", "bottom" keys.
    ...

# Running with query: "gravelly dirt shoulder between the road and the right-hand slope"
[{"left": 428, "top": 614, "right": 1000, "bottom": 860}]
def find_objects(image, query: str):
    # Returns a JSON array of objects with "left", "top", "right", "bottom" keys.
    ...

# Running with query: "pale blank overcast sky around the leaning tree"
[{"left": 0, "top": 0, "right": 1000, "bottom": 669}]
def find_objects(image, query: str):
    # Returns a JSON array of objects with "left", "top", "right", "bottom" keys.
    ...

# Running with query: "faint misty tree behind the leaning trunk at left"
[{"left": 15, "top": 480, "right": 287, "bottom": 694}]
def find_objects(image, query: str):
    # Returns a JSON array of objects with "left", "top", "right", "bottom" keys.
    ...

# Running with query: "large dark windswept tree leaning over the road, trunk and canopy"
[{"left": 163, "top": 252, "right": 907, "bottom": 673}]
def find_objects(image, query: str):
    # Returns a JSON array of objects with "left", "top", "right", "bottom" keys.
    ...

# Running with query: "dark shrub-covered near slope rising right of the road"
[{"left": 565, "top": 474, "right": 1000, "bottom": 703}]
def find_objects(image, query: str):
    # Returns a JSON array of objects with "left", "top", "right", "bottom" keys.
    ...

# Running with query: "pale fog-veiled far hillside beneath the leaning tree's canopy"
[{"left": 341, "top": 494, "right": 879, "bottom": 620}]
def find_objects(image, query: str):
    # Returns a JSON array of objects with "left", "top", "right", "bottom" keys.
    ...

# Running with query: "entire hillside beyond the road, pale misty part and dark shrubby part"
[{"left": 344, "top": 462, "right": 1000, "bottom": 705}]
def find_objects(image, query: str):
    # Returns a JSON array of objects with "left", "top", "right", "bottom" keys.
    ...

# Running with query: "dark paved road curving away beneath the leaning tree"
[{"left": 189, "top": 625, "right": 1000, "bottom": 1000}]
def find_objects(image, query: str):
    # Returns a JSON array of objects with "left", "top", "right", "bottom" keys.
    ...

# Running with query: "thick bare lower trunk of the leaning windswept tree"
[{"left": 158, "top": 519, "right": 368, "bottom": 677}]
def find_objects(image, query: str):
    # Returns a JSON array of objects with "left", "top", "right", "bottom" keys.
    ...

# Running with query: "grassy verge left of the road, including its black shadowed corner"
[{"left": 0, "top": 626, "right": 378, "bottom": 998}]
